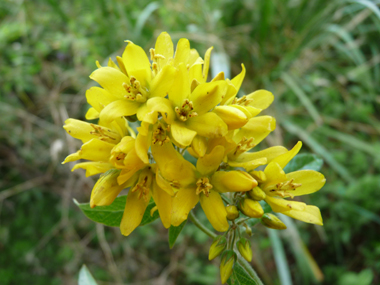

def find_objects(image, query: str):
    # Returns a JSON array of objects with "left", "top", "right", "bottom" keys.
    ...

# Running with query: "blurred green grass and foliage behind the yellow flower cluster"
[{"left": 0, "top": 0, "right": 380, "bottom": 285}]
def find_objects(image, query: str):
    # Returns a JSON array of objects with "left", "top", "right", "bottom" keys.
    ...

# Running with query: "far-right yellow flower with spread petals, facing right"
[{"left": 259, "top": 142, "right": 326, "bottom": 225}]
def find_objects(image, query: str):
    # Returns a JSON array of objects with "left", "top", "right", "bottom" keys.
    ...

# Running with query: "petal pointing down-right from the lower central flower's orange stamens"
[{"left": 199, "top": 191, "right": 229, "bottom": 232}]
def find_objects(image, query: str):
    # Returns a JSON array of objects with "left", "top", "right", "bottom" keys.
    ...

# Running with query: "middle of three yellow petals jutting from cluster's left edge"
[{"left": 63, "top": 139, "right": 115, "bottom": 163}]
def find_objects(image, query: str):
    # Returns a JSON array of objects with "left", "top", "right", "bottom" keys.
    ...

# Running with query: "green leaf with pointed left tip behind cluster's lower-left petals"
[{"left": 74, "top": 195, "right": 159, "bottom": 227}]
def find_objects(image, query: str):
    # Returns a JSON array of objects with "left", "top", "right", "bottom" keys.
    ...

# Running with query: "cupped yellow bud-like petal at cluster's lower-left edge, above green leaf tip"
[{"left": 90, "top": 169, "right": 125, "bottom": 208}]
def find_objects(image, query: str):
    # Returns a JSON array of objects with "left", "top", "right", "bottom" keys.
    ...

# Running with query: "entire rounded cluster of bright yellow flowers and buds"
[{"left": 64, "top": 32, "right": 325, "bottom": 237}]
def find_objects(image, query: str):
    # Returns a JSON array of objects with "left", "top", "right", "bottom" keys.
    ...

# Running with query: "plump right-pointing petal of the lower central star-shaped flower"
[{"left": 211, "top": 171, "right": 257, "bottom": 193}]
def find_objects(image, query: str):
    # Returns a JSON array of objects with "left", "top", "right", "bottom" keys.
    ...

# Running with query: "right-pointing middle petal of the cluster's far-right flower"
[{"left": 286, "top": 170, "right": 326, "bottom": 196}]
